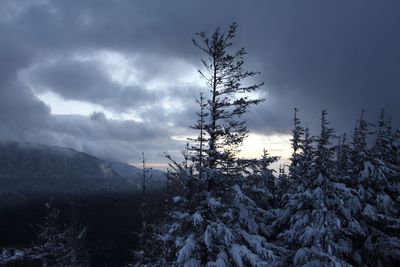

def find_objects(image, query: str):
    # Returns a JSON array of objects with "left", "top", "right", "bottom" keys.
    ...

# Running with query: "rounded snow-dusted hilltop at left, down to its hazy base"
[{"left": 0, "top": 142, "right": 119, "bottom": 179}]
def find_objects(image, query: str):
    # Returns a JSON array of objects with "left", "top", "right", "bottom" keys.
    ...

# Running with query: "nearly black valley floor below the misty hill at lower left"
[{"left": 0, "top": 192, "right": 165, "bottom": 266}]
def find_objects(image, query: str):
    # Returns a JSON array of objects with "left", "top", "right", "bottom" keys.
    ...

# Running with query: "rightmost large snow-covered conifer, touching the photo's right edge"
[{"left": 354, "top": 111, "right": 400, "bottom": 266}]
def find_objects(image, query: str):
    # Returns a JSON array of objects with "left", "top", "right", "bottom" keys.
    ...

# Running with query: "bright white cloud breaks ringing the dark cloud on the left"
[{"left": 23, "top": 50, "right": 204, "bottom": 120}]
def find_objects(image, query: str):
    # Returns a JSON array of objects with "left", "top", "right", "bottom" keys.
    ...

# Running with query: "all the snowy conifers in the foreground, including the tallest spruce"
[{"left": 1, "top": 24, "right": 400, "bottom": 267}]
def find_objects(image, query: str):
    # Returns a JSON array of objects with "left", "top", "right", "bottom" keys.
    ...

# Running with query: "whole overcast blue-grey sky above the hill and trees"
[{"left": 0, "top": 0, "right": 400, "bottom": 168}]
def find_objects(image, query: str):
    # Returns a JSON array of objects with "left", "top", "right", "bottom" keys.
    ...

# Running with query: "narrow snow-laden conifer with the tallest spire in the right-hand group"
[{"left": 294, "top": 110, "right": 359, "bottom": 266}]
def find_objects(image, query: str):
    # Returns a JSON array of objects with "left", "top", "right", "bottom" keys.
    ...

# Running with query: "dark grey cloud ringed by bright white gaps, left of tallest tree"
[{"left": 25, "top": 59, "right": 161, "bottom": 112}]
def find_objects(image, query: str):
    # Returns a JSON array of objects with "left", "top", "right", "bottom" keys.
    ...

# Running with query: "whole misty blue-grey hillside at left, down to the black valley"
[{"left": 0, "top": 141, "right": 164, "bottom": 207}]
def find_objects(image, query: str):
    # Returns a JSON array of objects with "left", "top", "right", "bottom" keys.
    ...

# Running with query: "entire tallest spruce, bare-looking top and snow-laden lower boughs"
[{"left": 159, "top": 23, "right": 284, "bottom": 266}]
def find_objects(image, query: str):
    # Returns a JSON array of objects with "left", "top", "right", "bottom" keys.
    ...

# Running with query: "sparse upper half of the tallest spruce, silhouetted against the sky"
[{"left": 193, "top": 23, "right": 263, "bottom": 176}]
